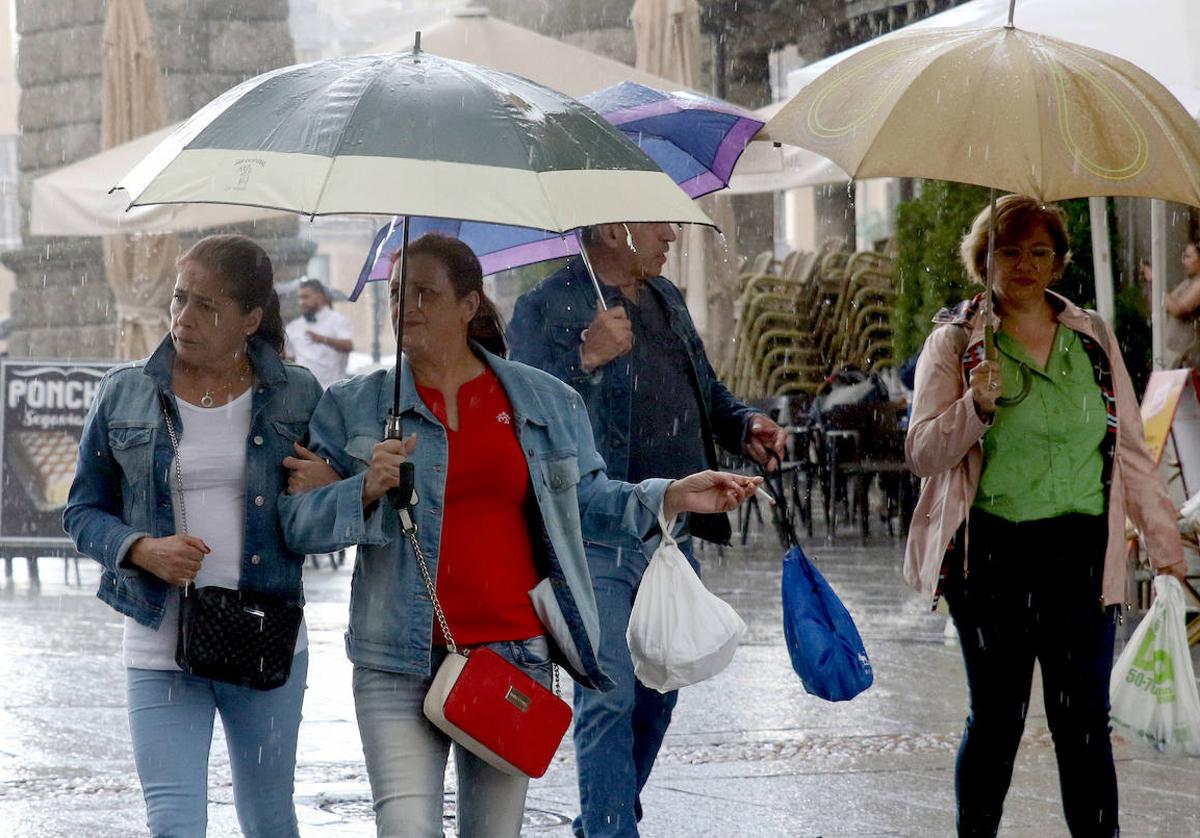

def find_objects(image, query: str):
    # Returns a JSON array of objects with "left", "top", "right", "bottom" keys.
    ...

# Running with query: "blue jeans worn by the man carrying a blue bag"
[{"left": 574, "top": 540, "right": 700, "bottom": 838}]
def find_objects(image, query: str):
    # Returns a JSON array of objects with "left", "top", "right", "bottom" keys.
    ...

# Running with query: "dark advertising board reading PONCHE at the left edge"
[{"left": 0, "top": 360, "right": 112, "bottom": 547}]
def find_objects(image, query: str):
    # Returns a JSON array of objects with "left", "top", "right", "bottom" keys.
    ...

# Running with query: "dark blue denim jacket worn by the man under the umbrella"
[{"left": 508, "top": 258, "right": 756, "bottom": 546}]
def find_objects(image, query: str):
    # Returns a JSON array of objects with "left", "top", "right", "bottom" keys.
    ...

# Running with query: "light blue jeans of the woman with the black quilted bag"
[{"left": 126, "top": 650, "right": 308, "bottom": 838}]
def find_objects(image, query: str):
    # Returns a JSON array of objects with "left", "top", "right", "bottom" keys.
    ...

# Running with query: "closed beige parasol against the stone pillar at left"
[{"left": 101, "top": 0, "right": 179, "bottom": 358}]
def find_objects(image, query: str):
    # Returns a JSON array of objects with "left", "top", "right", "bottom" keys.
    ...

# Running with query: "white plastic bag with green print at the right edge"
[{"left": 1109, "top": 575, "right": 1200, "bottom": 756}]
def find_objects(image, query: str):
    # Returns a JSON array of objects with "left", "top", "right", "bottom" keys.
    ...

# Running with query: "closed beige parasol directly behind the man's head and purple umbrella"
[{"left": 630, "top": 0, "right": 737, "bottom": 361}]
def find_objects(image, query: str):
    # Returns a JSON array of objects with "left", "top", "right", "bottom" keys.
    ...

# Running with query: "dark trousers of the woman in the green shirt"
[{"left": 944, "top": 509, "right": 1120, "bottom": 838}]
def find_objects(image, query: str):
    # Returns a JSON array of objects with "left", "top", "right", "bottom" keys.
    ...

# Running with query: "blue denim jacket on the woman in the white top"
[{"left": 62, "top": 336, "right": 320, "bottom": 629}]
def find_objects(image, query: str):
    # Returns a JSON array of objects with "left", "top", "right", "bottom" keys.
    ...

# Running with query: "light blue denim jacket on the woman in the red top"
[{"left": 280, "top": 347, "right": 670, "bottom": 689}]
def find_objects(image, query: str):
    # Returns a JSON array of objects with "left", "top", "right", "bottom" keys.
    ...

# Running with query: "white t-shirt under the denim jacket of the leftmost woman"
[{"left": 122, "top": 388, "right": 308, "bottom": 670}]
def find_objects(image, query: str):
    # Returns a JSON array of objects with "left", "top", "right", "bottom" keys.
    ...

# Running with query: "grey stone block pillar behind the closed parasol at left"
[{"left": 0, "top": 0, "right": 312, "bottom": 359}]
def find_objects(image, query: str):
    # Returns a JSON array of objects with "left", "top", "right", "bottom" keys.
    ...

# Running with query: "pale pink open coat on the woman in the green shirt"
[{"left": 904, "top": 292, "right": 1183, "bottom": 604}]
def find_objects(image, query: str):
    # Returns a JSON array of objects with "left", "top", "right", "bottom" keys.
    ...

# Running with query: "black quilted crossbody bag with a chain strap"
[{"left": 163, "top": 405, "right": 304, "bottom": 689}]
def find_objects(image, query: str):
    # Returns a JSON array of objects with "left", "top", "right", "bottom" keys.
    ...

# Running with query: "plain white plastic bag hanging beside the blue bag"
[{"left": 625, "top": 513, "right": 746, "bottom": 693}]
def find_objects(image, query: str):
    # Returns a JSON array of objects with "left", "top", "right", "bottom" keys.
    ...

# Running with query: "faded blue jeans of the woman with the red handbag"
[{"left": 354, "top": 636, "right": 553, "bottom": 838}]
